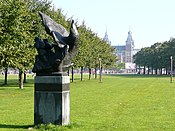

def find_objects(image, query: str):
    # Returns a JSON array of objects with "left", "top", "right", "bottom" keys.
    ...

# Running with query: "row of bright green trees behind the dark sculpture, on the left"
[{"left": 0, "top": 0, "right": 116, "bottom": 88}]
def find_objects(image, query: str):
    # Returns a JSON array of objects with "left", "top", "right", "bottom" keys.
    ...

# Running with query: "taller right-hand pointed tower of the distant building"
[{"left": 125, "top": 31, "right": 134, "bottom": 63}]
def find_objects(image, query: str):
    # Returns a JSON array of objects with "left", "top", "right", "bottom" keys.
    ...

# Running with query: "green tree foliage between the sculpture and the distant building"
[{"left": 74, "top": 22, "right": 116, "bottom": 68}]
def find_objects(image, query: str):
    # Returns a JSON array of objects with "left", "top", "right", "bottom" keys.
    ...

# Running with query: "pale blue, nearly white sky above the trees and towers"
[{"left": 52, "top": 0, "right": 175, "bottom": 48}]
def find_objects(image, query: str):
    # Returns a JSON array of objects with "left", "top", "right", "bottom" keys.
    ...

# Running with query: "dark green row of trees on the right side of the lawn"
[{"left": 134, "top": 39, "right": 175, "bottom": 74}]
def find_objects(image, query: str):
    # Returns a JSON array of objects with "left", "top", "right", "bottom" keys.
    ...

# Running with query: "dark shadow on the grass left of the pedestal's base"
[{"left": 0, "top": 124, "right": 34, "bottom": 130}]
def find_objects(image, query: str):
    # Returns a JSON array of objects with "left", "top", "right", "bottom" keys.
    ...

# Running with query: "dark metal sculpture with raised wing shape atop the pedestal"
[{"left": 32, "top": 12, "right": 78, "bottom": 73}]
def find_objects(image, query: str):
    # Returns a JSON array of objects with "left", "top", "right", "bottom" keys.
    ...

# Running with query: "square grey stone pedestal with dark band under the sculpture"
[{"left": 34, "top": 74, "right": 70, "bottom": 125}]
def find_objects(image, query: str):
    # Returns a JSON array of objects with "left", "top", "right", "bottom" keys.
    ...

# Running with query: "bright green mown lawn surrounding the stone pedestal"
[{"left": 0, "top": 75, "right": 175, "bottom": 131}]
